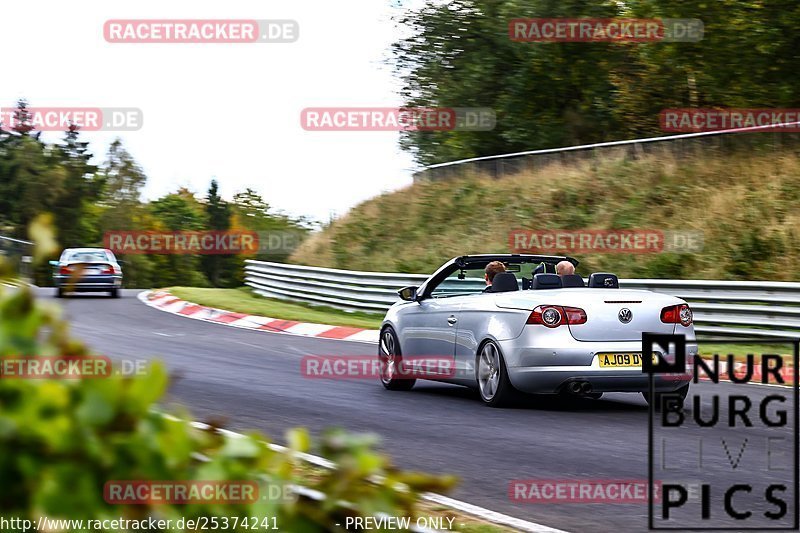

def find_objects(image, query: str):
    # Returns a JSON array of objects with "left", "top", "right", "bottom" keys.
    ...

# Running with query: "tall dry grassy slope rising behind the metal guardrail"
[{"left": 289, "top": 150, "right": 800, "bottom": 281}]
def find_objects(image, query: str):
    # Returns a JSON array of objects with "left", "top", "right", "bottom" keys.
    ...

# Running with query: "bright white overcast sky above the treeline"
[{"left": 0, "top": 0, "right": 420, "bottom": 220}]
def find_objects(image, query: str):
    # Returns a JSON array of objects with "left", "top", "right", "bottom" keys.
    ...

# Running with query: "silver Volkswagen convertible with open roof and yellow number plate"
[{"left": 378, "top": 254, "right": 697, "bottom": 408}]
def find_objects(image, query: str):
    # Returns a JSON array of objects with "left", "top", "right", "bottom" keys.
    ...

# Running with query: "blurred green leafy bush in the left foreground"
[{"left": 0, "top": 280, "right": 453, "bottom": 531}]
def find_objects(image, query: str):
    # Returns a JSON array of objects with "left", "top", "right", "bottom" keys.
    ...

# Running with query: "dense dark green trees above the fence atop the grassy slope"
[{"left": 393, "top": 0, "right": 800, "bottom": 165}]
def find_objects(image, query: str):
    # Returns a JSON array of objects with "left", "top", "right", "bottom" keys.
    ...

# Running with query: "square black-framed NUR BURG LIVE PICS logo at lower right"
[{"left": 642, "top": 333, "right": 800, "bottom": 531}]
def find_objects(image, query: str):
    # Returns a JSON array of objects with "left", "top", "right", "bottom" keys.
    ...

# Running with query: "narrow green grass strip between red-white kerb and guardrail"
[{"left": 167, "top": 287, "right": 383, "bottom": 329}]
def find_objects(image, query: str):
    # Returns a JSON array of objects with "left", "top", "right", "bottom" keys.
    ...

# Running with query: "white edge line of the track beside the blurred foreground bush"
[{"left": 175, "top": 414, "right": 567, "bottom": 533}]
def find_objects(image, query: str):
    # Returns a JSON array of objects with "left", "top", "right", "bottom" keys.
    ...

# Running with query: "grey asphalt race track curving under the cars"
[{"left": 48, "top": 289, "right": 792, "bottom": 531}]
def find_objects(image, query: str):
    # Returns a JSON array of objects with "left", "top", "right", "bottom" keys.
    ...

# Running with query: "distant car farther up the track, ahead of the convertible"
[{"left": 50, "top": 248, "right": 122, "bottom": 298}]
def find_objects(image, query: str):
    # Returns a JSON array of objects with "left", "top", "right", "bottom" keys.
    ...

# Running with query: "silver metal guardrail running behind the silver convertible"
[{"left": 245, "top": 260, "right": 800, "bottom": 338}]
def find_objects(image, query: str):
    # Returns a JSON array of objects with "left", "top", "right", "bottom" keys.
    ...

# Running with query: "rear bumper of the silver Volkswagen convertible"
[{"left": 499, "top": 328, "right": 697, "bottom": 393}]
